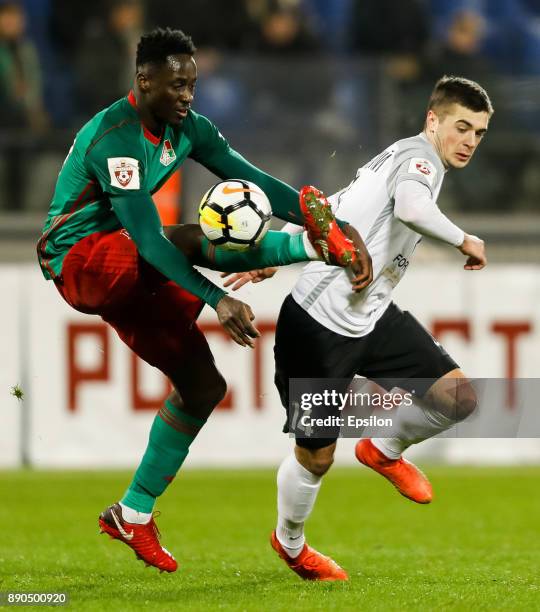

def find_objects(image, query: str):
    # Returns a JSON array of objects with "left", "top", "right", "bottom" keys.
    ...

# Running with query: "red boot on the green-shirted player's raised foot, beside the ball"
[{"left": 300, "top": 185, "right": 358, "bottom": 268}]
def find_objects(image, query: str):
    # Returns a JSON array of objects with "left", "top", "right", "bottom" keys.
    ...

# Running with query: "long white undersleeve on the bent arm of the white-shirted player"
[{"left": 394, "top": 180, "right": 465, "bottom": 246}]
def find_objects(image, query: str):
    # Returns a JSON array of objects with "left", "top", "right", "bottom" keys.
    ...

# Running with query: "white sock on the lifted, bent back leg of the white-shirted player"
[{"left": 371, "top": 402, "right": 455, "bottom": 459}]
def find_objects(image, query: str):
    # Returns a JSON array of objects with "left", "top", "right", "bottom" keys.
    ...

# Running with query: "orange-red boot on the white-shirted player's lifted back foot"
[{"left": 355, "top": 438, "right": 433, "bottom": 504}]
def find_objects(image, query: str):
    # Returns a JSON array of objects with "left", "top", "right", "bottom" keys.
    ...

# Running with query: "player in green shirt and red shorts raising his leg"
[{"left": 38, "top": 29, "right": 371, "bottom": 572}]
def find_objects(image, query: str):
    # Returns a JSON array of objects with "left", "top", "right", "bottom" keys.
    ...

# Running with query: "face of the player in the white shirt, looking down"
[{"left": 427, "top": 104, "right": 489, "bottom": 168}]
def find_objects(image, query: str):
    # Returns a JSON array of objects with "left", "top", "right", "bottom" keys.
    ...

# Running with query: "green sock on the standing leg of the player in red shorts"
[{"left": 120, "top": 400, "right": 206, "bottom": 512}]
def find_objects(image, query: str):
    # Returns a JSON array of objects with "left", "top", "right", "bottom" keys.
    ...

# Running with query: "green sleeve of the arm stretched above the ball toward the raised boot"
[{"left": 189, "top": 113, "right": 304, "bottom": 225}]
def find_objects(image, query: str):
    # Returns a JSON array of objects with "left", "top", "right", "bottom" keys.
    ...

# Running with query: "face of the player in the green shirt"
[{"left": 147, "top": 55, "right": 197, "bottom": 125}]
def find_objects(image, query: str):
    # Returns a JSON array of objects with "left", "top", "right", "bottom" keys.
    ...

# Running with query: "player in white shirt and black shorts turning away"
[{"left": 224, "top": 77, "right": 493, "bottom": 580}]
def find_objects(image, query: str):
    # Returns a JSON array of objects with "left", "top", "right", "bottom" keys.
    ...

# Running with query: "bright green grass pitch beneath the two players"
[{"left": 0, "top": 467, "right": 540, "bottom": 611}]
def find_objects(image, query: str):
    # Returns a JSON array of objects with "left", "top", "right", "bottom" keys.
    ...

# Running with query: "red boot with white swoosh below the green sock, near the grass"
[{"left": 99, "top": 504, "right": 178, "bottom": 572}]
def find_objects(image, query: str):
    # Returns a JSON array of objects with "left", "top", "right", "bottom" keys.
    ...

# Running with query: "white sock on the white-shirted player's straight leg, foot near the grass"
[{"left": 276, "top": 453, "right": 322, "bottom": 558}]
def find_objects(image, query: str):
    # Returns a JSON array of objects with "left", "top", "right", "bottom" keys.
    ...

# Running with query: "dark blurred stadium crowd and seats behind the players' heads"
[{"left": 0, "top": 0, "right": 540, "bottom": 226}]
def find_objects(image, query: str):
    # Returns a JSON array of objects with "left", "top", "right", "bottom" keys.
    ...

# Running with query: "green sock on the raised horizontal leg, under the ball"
[{"left": 202, "top": 231, "right": 309, "bottom": 272}]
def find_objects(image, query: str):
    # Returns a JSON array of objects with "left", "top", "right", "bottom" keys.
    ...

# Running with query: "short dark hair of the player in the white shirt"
[{"left": 427, "top": 75, "right": 494, "bottom": 116}]
